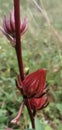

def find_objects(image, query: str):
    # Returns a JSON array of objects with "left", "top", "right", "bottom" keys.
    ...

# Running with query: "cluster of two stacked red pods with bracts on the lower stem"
[{"left": 16, "top": 68, "right": 48, "bottom": 110}]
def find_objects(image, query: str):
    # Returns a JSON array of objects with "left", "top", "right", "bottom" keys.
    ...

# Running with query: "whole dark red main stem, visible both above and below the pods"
[{"left": 14, "top": 0, "right": 35, "bottom": 129}]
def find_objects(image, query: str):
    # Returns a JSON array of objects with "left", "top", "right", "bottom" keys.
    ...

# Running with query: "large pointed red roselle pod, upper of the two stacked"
[{"left": 23, "top": 68, "right": 46, "bottom": 97}]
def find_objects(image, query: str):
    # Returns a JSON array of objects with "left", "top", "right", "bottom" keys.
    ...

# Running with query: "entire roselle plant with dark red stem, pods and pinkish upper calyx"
[{"left": 0, "top": 0, "right": 48, "bottom": 129}]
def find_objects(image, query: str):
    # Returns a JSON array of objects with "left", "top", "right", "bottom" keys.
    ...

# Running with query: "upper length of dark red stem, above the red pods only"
[{"left": 14, "top": 0, "right": 24, "bottom": 80}]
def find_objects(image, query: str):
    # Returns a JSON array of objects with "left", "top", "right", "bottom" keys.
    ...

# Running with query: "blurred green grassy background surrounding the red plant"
[{"left": 0, "top": 0, "right": 62, "bottom": 130}]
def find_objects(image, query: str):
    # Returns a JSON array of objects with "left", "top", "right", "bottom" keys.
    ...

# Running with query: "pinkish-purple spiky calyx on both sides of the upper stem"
[{"left": 0, "top": 9, "right": 28, "bottom": 46}]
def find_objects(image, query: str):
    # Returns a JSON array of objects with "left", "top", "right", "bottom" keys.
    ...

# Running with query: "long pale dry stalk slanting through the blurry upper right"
[{"left": 32, "top": 0, "right": 62, "bottom": 64}]
